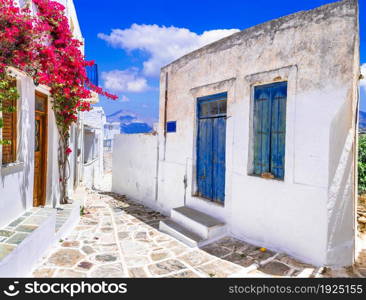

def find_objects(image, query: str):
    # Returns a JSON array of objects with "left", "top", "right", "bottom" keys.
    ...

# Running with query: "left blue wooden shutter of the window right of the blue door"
[{"left": 253, "top": 86, "right": 271, "bottom": 175}]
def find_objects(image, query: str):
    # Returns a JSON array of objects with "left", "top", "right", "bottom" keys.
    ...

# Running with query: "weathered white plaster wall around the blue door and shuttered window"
[{"left": 158, "top": 0, "right": 359, "bottom": 265}]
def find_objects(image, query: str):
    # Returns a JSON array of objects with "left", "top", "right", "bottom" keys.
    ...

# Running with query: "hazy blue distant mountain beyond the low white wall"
[{"left": 107, "top": 109, "right": 153, "bottom": 134}]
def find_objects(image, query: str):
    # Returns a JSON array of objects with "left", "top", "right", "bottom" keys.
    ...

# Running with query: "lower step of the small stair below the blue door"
[{"left": 159, "top": 219, "right": 204, "bottom": 247}]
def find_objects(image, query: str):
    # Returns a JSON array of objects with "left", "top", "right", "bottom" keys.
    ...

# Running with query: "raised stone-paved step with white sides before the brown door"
[{"left": 0, "top": 201, "right": 80, "bottom": 278}]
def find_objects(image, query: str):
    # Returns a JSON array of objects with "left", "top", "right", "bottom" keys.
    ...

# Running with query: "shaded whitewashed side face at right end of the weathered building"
[{"left": 327, "top": 98, "right": 355, "bottom": 265}]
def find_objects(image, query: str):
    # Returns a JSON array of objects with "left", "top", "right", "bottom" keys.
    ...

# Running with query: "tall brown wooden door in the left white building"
[{"left": 33, "top": 93, "right": 47, "bottom": 206}]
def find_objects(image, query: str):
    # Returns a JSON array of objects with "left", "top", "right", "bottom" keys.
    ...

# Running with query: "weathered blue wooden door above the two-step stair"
[{"left": 197, "top": 93, "right": 227, "bottom": 202}]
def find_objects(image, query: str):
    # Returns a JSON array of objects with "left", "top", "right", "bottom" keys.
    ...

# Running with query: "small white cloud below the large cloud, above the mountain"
[{"left": 102, "top": 68, "right": 149, "bottom": 92}]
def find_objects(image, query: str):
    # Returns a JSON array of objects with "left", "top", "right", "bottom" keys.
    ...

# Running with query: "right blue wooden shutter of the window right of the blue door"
[{"left": 271, "top": 83, "right": 287, "bottom": 179}]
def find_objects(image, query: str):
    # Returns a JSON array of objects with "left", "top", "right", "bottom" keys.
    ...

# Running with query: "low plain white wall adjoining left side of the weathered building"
[{"left": 112, "top": 134, "right": 158, "bottom": 208}]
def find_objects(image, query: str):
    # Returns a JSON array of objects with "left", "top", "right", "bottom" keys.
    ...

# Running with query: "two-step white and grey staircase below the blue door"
[{"left": 159, "top": 206, "right": 226, "bottom": 247}]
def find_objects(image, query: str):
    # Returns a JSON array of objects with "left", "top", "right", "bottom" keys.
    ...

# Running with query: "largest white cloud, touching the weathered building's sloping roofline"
[{"left": 98, "top": 24, "right": 239, "bottom": 76}]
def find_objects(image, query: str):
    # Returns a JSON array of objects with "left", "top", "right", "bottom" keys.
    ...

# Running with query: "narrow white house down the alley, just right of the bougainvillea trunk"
[{"left": 82, "top": 107, "right": 106, "bottom": 188}]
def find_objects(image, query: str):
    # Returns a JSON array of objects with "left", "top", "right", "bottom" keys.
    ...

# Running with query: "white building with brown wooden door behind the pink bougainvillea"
[{"left": 0, "top": 0, "right": 98, "bottom": 277}]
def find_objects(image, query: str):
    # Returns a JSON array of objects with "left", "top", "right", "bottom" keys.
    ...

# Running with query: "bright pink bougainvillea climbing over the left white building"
[{"left": 0, "top": 0, "right": 117, "bottom": 203}]
